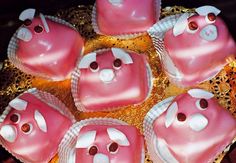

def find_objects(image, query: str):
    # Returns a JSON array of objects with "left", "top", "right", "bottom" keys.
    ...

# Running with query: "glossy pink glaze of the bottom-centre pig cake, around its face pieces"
[{"left": 76, "top": 125, "right": 144, "bottom": 163}]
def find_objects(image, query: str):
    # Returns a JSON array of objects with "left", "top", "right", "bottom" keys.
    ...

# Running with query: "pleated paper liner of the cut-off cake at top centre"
[{"left": 92, "top": 0, "right": 161, "bottom": 39}]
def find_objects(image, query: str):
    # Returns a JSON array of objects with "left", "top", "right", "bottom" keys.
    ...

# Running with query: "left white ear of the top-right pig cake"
[{"left": 173, "top": 13, "right": 189, "bottom": 36}]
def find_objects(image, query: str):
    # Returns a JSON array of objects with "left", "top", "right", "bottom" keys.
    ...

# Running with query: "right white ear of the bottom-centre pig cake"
[{"left": 107, "top": 128, "right": 130, "bottom": 146}]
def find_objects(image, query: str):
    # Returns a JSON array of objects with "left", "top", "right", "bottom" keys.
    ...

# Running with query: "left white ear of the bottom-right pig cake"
[{"left": 165, "top": 102, "right": 178, "bottom": 128}]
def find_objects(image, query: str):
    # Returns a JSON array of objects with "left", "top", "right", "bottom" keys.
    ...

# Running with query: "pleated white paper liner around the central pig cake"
[{"left": 71, "top": 48, "right": 153, "bottom": 112}]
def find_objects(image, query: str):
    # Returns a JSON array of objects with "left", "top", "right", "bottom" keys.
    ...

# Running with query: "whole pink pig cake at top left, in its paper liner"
[{"left": 8, "top": 9, "right": 84, "bottom": 80}]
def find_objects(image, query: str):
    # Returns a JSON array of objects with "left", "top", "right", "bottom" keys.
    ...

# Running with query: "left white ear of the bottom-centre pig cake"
[{"left": 76, "top": 131, "right": 96, "bottom": 148}]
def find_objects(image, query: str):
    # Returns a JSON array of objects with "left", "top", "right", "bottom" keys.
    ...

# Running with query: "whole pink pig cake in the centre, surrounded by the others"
[{"left": 72, "top": 48, "right": 151, "bottom": 112}]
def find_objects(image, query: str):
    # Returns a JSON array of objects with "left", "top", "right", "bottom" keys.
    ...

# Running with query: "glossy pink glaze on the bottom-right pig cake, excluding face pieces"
[{"left": 153, "top": 91, "right": 236, "bottom": 163}]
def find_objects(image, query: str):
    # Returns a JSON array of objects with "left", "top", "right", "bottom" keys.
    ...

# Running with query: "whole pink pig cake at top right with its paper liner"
[{"left": 149, "top": 6, "right": 236, "bottom": 87}]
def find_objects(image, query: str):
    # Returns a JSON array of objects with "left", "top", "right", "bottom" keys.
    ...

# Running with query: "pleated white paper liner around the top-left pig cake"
[{"left": 7, "top": 15, "right": 76, "bottom": 80}]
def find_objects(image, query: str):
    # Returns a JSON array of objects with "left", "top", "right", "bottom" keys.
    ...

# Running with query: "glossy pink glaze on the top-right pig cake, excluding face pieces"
[{"left": 164, "top": 16, "right": 236, "bottom": 86}]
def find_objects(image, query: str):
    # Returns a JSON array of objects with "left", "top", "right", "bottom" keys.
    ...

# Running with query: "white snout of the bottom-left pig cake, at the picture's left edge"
[{"left": 0, "top": 125, "right": 17, "bottom": 143}]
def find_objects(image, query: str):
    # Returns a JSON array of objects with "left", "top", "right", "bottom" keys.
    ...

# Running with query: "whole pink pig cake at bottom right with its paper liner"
[{"left": 144, "top": 89, "right": 236, "bottom": 163}]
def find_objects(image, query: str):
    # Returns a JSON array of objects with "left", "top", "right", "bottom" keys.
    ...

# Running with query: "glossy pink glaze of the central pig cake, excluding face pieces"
[{"left": 78, "top": 50, "right": 149, "bottom": 111}]
